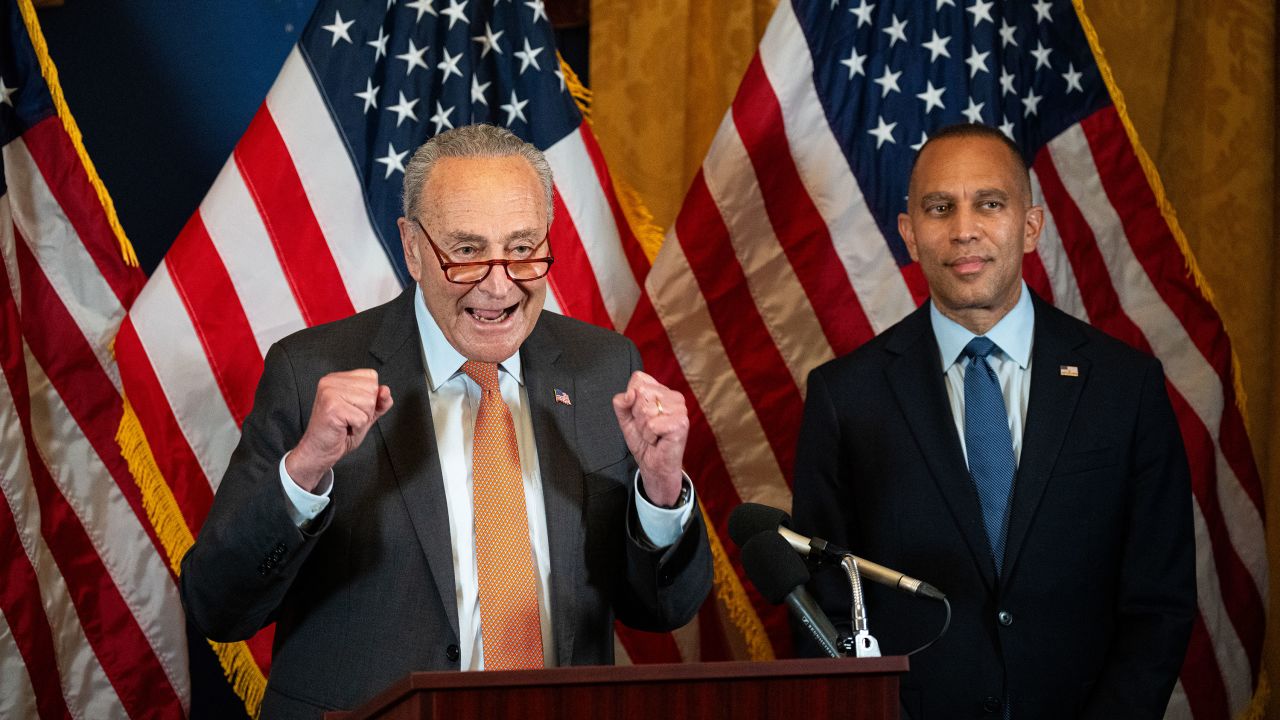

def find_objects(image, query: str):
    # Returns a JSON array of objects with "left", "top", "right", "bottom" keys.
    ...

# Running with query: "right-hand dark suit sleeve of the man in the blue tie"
[{"left": 1082, "top": 361, "right": 1196, "bottom": 720}]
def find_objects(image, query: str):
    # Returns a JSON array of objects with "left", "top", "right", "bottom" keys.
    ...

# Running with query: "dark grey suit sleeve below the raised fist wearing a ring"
[{"left": 613, "top": 342, "right": 712, "bottom": 632}]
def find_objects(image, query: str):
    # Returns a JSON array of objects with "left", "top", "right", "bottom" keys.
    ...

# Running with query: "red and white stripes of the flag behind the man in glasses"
[{"left": 115, "top": 40, "right": 680, "bottom": 696}]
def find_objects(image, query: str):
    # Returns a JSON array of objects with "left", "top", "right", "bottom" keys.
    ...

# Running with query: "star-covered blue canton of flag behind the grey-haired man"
[{"left": 298, "top": 0, "right": 581, "bottom": 283}]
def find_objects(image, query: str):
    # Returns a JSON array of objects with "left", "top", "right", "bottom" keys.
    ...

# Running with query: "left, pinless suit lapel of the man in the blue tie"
[{"left": 884, "top": 304, "right": 996, "bottom": 588}]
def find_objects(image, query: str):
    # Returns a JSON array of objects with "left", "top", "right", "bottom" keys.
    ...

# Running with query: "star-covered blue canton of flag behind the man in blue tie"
[{"left": 794, "top": 0, "right": 1111, "bottom": 266}]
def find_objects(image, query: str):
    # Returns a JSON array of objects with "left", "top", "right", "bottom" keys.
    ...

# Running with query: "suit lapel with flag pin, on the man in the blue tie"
[{"left": 1005, "top": 295, "right": 1089, "bottom": 577}]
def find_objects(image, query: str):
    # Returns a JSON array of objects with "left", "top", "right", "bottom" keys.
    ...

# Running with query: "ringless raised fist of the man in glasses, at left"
[{"left": 284, "top": 369, "right": 392, "bottom": 492}]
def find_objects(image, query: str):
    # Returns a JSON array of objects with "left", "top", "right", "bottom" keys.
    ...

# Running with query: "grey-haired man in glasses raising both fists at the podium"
[{"left": 180, "top": 126, "right": 712, "bottom": 719}]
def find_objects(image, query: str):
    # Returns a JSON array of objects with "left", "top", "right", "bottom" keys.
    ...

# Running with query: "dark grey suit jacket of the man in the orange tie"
[{"left": 180, "top": 290, "right": 712, "bottom": 719}]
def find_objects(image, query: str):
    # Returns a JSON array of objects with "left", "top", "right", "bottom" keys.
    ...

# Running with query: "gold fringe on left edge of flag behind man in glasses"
[{"left": 115, "top": 393, "right": 266, "bottom": 717}]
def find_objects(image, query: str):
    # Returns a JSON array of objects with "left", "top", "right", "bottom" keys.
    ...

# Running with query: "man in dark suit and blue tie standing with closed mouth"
[{"left": 794, "top": 120, "right": 1196, "bottom": 720}]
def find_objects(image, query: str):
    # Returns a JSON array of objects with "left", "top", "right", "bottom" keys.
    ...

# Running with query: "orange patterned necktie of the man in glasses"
[{"left": 462, "top": 360, "right": 543, "bottom": 670}]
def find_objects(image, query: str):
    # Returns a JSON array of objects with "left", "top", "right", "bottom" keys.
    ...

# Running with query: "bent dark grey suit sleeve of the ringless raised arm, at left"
[{"left": 179, "top": 346, "right": 333, "bottom": 642}]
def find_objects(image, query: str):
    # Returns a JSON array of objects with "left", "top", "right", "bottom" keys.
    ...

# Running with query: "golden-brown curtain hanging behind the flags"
[{"left": 591, "top": 0, "right": 1280, "bottom": 717}]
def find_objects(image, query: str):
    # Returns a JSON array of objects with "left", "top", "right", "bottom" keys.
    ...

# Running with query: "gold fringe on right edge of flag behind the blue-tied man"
[{"left": 1071, "top": 0, "right": 1271, "bottom": 720}]
